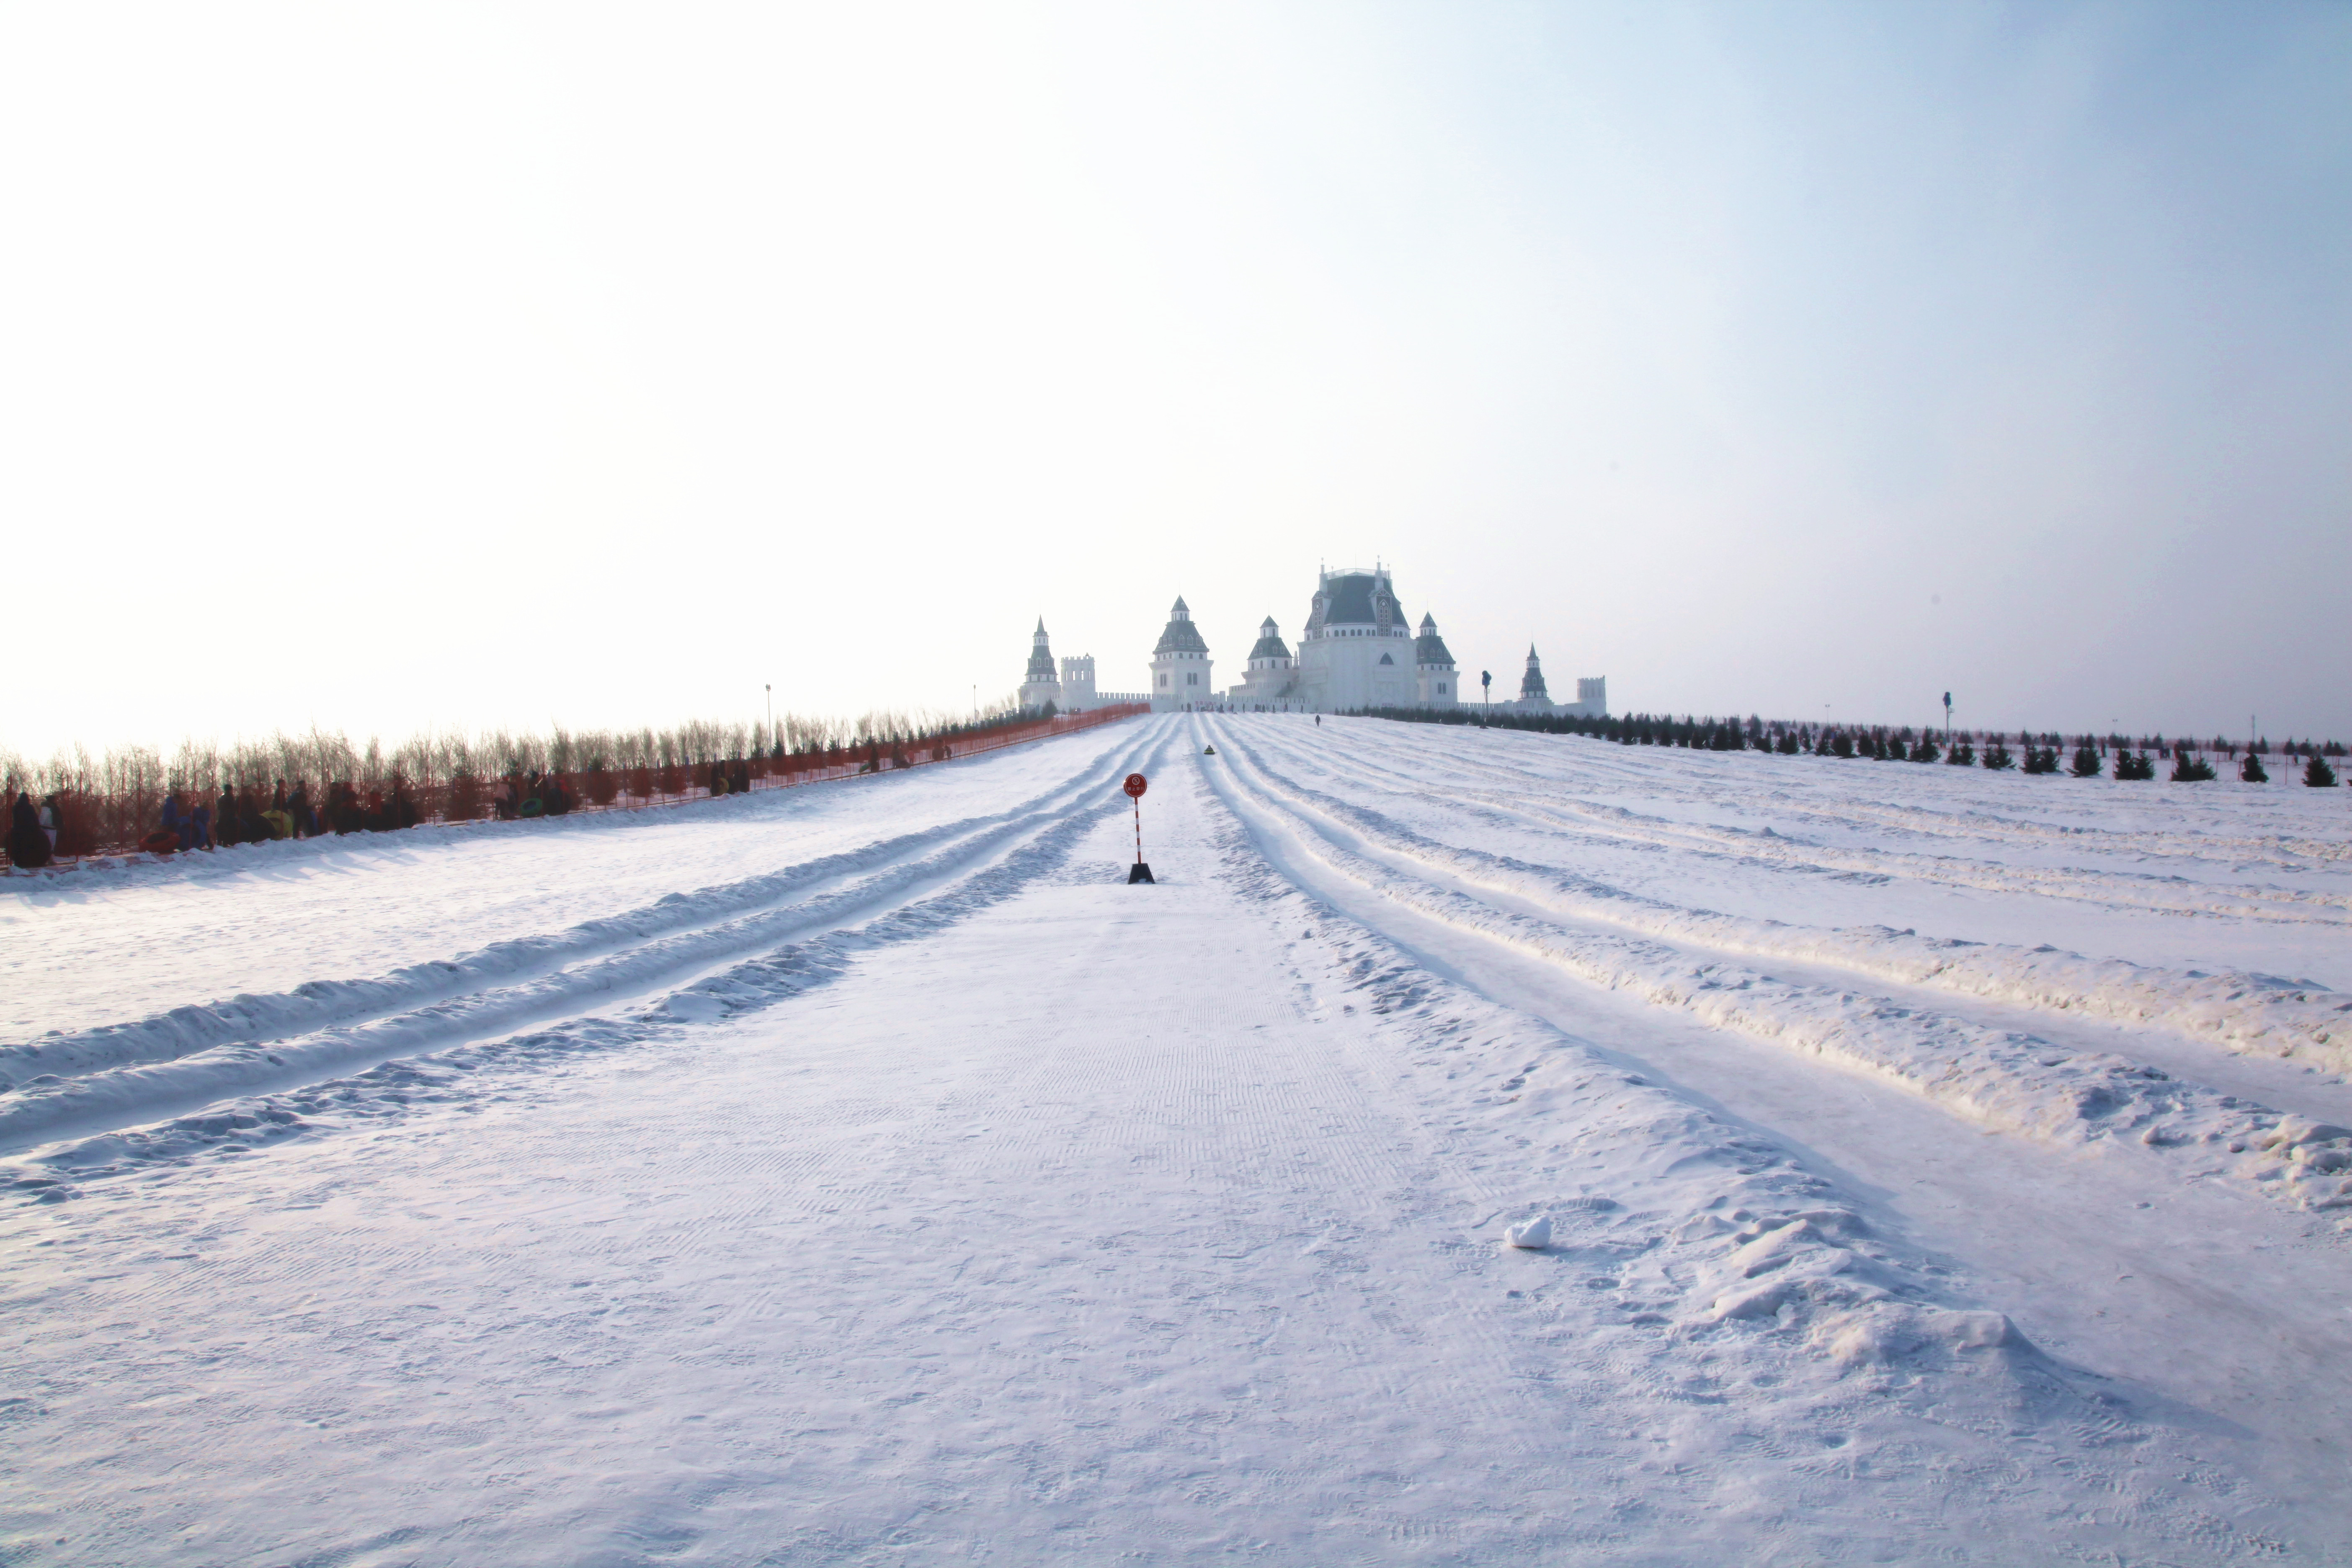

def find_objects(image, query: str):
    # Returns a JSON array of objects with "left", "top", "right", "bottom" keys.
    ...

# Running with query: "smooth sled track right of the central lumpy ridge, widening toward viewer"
[{"left": 1204, "top": 720, "right": 2352, "bottom": 1561}]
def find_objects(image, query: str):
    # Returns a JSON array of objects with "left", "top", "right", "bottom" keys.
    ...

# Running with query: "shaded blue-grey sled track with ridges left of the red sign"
[{"left": 0, "top": 733, "right": 1164, "bottom": 1154}]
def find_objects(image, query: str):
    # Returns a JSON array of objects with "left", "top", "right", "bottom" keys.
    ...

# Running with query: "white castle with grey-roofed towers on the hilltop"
[{"left": 1021, "top": 567, "right": 1609, "bottom": 720}]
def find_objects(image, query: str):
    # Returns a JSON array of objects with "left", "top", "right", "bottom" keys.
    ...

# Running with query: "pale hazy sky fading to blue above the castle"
[{"left": 0, "top": 5, "right": 2352, "bottom": 755}]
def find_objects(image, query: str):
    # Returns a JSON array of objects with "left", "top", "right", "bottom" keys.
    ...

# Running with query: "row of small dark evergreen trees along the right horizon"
[{"left": 1359, "top": 708, "right": 2345, "bottom": 790}]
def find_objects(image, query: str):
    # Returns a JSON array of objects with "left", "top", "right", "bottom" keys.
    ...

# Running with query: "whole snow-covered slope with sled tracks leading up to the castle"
[{"left": 0, "top": 714, "right": 2352, "bottom": 1568}]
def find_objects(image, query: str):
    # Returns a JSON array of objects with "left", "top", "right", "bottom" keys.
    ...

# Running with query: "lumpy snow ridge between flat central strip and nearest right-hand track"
[{"left": 1176, "top": 720, "right": 2333, "bottom": 1561}]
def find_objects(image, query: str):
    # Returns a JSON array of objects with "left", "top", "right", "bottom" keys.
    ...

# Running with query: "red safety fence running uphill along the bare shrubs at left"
[{"left": 9, "top": 703, "right": 1150, "bottom": 867}]
